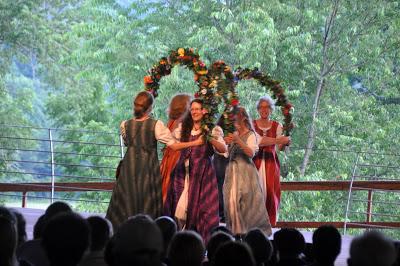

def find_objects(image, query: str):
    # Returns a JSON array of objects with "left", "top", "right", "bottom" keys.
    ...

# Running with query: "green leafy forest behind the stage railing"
[{"left": 0, "top": 0, "right": 400, "bottom": 238}]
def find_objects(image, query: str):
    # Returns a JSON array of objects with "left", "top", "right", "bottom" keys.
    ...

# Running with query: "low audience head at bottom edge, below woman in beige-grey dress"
[{"left": 214, "top": 241, "right": 256, "bottom": 266}]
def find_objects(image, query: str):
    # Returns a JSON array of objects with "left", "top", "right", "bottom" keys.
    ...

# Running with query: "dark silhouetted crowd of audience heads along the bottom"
[{"left": 0, "top": 202, "right": 400, "bottom": 266}]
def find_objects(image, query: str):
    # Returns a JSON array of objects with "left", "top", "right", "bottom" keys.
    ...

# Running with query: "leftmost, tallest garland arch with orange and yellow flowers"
[{"left": 144, "top": 48, "right": 218, "bottom": 139}]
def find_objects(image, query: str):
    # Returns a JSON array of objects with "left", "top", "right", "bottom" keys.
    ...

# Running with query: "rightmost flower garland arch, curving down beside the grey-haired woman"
[{"left": 234, "top": 67, "right": 294, "bottom": 136}]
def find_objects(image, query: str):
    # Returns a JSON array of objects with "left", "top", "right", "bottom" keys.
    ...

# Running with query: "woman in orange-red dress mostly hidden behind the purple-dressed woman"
[{"left": 160, "top": 94, "right": 191, "bottom": 203}]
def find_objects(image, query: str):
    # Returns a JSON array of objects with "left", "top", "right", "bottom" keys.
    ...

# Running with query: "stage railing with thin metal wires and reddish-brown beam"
[{"left": 0, "top": 125, "right": 400, "bottom": 232}]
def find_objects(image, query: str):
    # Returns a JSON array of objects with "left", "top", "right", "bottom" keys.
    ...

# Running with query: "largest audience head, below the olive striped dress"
[{"left": 109, "top": 214, "right": 163, "bottom": 266}]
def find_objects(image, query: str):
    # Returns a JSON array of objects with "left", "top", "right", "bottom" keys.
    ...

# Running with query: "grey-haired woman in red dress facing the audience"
[{"left": 253, "top": 96, "right": 290, "bottom": 226}]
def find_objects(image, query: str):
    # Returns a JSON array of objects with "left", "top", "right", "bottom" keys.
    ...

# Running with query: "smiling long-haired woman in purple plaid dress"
[{"left": 164, "top": 99, "right": 227, "bottom": 242}]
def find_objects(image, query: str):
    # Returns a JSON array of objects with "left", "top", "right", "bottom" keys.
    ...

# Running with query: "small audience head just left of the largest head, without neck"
[{"left": 86, "top": 216, "right": 112, "bottom": 251}]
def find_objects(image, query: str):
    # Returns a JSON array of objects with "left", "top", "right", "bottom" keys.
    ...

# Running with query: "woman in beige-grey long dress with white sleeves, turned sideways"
[{"left": 223, "top": 107, "right": 272, "bottom": 235}]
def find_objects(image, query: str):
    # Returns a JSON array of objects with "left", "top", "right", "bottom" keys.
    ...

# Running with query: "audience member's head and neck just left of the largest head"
[{"left": 79, "top": 216, "right": 112, "bottom": 266}]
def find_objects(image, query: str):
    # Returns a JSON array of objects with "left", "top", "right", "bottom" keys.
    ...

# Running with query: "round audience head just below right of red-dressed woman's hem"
[{"left": 274, "top": 228, "right": 306, "bottom": 259}]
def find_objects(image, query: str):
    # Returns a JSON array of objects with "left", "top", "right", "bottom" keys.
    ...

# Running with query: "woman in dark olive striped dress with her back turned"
[{"left": 106, "top": 91, "right": 203, "bottom": 230}]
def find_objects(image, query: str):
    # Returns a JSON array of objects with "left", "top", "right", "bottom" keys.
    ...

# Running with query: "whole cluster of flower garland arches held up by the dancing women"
[{"left": 144, "top": 48, "right": 294, "bottom": 139}]
